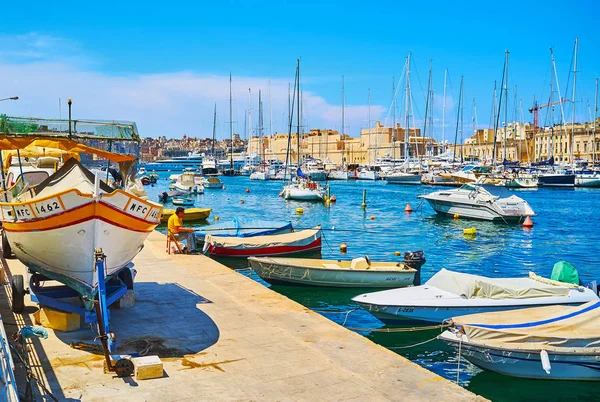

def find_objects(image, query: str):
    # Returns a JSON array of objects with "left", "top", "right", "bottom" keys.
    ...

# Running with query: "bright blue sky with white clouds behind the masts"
[{"left": 0, "top": 1, "right": 600, "bottom": 138}]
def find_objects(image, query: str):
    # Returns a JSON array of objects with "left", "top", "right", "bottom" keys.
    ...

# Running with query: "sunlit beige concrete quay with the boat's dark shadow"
[{"left": 1, "top": 233, "right": 483, "bottom": 401}]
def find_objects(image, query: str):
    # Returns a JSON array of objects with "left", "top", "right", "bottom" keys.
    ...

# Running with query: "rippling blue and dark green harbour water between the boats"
[{"left": 146, "top": 173, "right": 600, "bottom": 401}]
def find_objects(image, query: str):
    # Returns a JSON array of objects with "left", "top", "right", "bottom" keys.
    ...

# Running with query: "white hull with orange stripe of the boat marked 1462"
[{"left": 0, "top": 189, "right": 162, "bottom": 297}]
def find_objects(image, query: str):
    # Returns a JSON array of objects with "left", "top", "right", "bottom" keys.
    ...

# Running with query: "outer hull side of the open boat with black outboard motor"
[{"left": 249, "top": 258, "right": 415, "bottom": 288}]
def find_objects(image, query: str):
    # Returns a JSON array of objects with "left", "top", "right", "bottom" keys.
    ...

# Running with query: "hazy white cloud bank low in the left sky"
[{"left": 0, "top": 33, "right": 385, "bottom": 138}]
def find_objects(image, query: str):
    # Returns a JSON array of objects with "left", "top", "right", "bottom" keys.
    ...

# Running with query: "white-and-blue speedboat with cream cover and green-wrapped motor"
[{"left": 352, "top": 269, "right": 599, "bottom": 324}]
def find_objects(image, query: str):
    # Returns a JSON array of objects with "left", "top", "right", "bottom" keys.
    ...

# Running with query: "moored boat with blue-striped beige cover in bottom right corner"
[{"left": 439, "top": 300, "right": 600, "bottom": 381}]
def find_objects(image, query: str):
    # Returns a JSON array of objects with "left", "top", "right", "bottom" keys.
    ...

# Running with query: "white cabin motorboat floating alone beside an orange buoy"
[{"left": 417, "top": 183, "right": 535, "bottom": 222}]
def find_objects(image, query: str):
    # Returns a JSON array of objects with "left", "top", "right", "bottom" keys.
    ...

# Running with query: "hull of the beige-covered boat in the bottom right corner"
[{"left": 440, "top": 331, "right": 600, "bottom": 381}]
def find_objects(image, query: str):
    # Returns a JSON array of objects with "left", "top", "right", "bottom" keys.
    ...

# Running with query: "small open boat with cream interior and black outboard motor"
[{"left": 248, "top": 257, "right": 417, "bottom": 288}]
